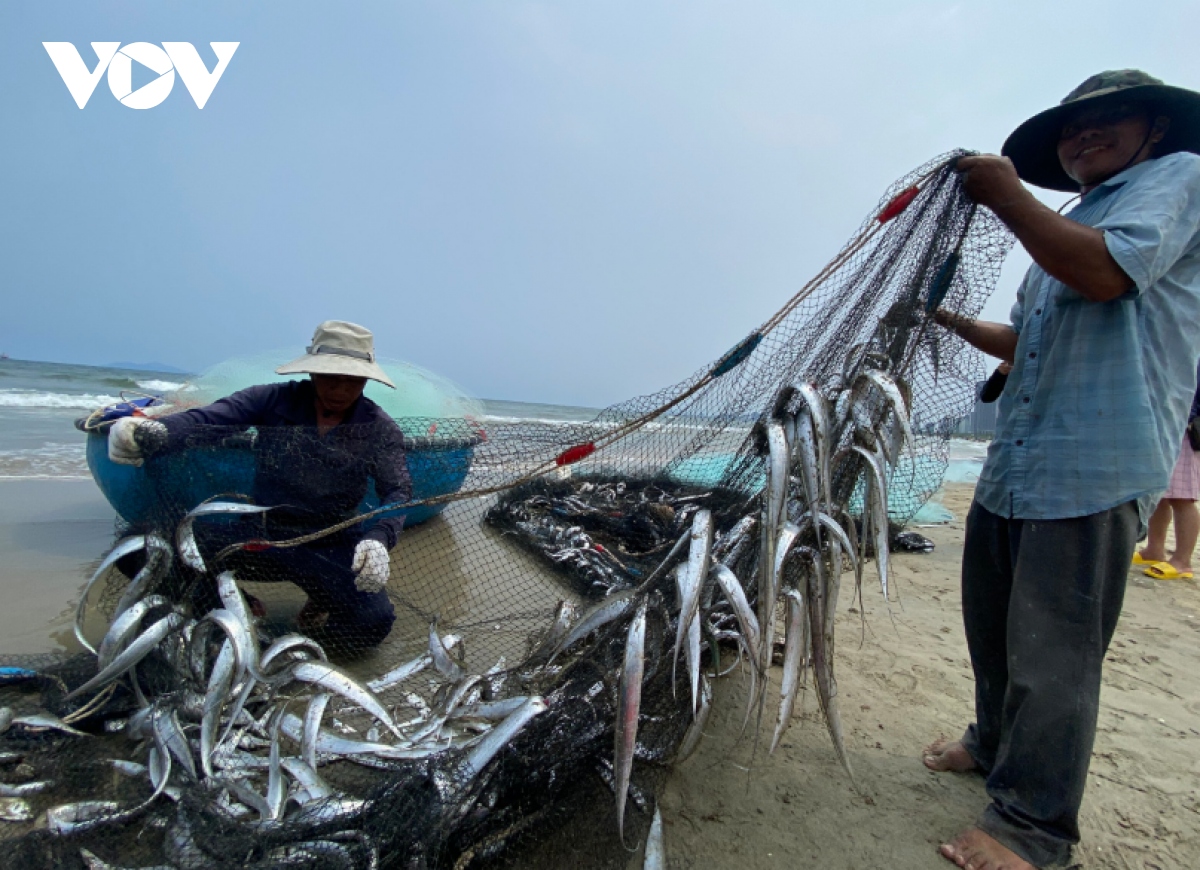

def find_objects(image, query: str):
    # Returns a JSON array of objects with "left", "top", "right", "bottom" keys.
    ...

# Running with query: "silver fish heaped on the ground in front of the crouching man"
[{"left": 0, "top": 502, "right": 559, "bottom": 868}]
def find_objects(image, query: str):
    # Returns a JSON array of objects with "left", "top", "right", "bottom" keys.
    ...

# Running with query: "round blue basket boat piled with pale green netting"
[{"left": 77, "top": 350, "right": 487, "bottom": 526}]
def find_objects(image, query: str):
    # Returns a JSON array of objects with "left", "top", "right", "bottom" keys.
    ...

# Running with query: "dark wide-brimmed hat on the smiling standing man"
[{"left": 1001, "top": 70, "right": 1200, "bottom": 193}]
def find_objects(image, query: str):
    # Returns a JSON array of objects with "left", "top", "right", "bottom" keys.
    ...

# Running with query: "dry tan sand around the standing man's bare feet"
[{"left": 662, "top": 484, "right": 1200, "bottom": 870}]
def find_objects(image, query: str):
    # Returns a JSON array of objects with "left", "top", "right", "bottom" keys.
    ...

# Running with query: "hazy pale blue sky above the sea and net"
[{"left": 0, "top": 0, "right": 1200, "bottom": 406}]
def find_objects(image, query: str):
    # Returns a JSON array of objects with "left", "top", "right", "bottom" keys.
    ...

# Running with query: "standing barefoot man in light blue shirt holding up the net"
[{"left": 924, "top": 70, "right": 1200, "bottom": 870}]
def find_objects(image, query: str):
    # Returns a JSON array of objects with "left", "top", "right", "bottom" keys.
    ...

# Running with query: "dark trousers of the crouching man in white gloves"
[{"left": 196, "top": 522, "right": 396, "bottom": 653}]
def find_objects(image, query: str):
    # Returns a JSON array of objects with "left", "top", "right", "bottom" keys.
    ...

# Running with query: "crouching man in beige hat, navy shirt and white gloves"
[{"left": 108, "top": 320, "right": 412, "bottom": 653}]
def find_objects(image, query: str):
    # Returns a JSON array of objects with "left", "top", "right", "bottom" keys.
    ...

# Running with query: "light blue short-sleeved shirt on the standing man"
[{"left": 976, "top": 154, "right": 1200, "bottom": 520}]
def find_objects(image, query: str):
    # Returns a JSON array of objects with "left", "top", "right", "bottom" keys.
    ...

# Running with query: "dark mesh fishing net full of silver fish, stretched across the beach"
[{"left": 0, "top": 154, "right": 1010, "bottom": 870}]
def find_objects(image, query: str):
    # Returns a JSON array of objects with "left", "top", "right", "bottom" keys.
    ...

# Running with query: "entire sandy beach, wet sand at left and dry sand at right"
[{"left": 0, "top": 481, "right": 1200, "bottom": 870}]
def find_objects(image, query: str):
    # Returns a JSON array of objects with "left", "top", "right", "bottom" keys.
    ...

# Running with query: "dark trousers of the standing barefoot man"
[{"left": 962, "top": 502, "right": 1138, "bottom": 866}]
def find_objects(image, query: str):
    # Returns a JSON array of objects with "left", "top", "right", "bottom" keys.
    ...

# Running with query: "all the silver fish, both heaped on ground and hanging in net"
[{"left": 0, "top": 359, "right": 913, "bottom": 869}]
